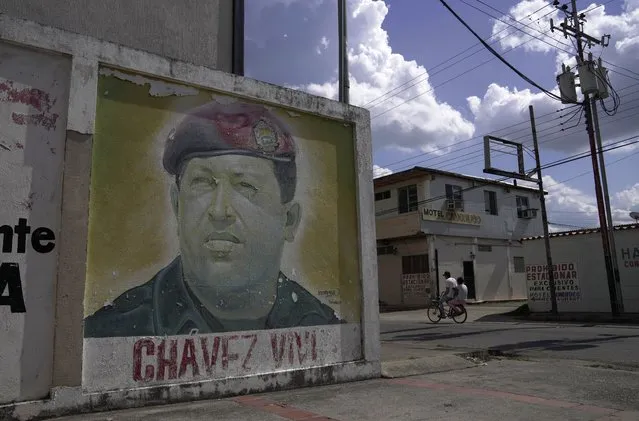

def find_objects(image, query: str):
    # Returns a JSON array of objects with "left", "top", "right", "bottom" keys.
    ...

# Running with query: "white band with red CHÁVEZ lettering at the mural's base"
[{"left": 83, "top": 324, "right": 362, "bottom": 392}]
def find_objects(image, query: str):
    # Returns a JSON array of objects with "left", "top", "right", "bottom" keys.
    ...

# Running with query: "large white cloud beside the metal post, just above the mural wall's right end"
[{"left": 297, "top": 0, "right": 474, "bottom": 151}]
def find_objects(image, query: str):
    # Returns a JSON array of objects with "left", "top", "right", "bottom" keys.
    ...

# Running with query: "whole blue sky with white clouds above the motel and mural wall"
[{"left": 245, "top": 0, "right": 639, "bottom": 228}]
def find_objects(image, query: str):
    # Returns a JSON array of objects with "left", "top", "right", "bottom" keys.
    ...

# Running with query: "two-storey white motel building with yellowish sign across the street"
[{"left": 374, "top": 167, "right": 543, "bottom": 307}]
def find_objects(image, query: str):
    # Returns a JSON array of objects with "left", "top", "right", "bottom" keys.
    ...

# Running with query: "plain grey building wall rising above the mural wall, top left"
[{"left": 0, "top": 0, "right": 233, "bottom": 72}]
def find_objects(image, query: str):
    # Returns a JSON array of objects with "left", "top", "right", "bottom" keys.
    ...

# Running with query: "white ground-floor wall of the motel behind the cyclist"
[{"left": 433, "top": 235, "right": 526, "bottom": 301}]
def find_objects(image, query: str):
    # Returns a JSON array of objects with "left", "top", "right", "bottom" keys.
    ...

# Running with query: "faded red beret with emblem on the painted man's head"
[{"left": 163, "top": 102, "right": 295, "bottom": 175}]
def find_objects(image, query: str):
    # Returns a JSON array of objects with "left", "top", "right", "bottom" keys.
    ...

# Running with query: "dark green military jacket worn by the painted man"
[{"left": 84, "top": 256, "right": 343, "bottom": 338}]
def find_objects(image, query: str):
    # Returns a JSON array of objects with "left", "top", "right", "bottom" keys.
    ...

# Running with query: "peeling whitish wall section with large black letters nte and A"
[{"left": 0, "top": 42, "right": 71, "bottom": 403}]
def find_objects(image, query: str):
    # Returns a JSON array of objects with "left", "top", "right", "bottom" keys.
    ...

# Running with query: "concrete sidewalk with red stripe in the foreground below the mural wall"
[{"left": 53, "top": 359, "right": 639, "bottom": 421}]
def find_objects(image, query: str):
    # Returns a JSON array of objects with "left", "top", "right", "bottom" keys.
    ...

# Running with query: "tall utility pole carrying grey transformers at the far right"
[{"left": 571, "top": 0, "right": 619, "bottom": 316}]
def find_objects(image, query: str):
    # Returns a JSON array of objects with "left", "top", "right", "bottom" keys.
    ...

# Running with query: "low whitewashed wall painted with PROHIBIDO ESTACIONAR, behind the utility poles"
[{"left": 523, "top": 226, "right": 639, "bottom": 313}]
